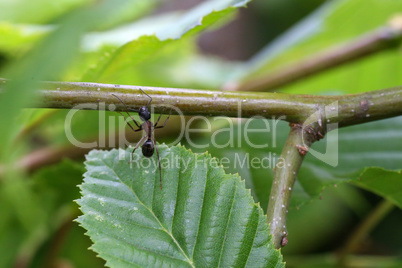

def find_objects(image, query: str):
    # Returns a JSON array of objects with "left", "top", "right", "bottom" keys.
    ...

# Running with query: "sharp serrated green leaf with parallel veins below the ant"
[{"left": 78, "top": 145, "right": 284, "bottom": 267}]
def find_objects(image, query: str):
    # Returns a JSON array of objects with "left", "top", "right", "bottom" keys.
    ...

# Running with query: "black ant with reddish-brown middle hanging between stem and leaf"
[{"left": 112, "top": 89, "right": 172, "bottom": 190}]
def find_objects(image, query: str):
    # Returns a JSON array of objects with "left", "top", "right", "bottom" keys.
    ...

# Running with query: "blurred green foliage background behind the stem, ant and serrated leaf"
[{"left": 0, "top": 0, "right": 402, "bottom": 267}]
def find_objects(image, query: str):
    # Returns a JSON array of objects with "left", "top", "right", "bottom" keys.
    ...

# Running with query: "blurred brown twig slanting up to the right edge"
[{"left": 228, "top": 20, "right": 402, "bottom": 91}]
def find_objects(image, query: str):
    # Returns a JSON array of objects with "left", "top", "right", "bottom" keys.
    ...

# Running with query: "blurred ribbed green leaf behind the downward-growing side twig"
[{"left": 187, "top": 117, "right": 402, "bottom": 209}]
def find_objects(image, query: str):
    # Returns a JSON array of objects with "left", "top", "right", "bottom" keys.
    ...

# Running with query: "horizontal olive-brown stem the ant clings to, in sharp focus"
[{"left": 0, "top": 79, "right": 402, "bottom": 126}]
